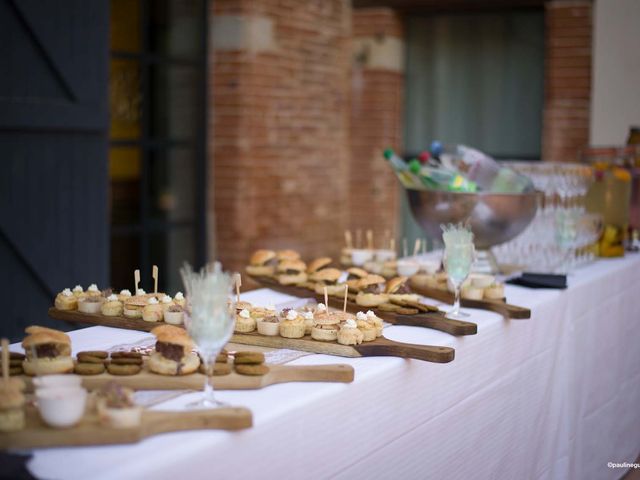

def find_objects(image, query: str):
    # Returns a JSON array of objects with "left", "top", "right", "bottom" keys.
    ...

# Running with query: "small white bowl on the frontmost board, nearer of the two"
[{"left": 36, "top": 387, "right": 87, "bottom": 428}]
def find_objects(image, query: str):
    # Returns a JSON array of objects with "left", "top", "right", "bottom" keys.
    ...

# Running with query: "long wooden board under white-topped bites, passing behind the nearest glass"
[{"left": 49, "top": 308, "right": 455, "bottom": 363}]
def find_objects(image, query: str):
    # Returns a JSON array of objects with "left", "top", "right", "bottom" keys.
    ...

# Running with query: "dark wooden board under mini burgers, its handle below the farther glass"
[{"left": 251, "top": 277, "right": 478, "bottom": 336}]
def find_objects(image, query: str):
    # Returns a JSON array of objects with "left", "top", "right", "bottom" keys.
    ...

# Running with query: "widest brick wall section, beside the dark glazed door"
[{"left": 208, "top": 0, "right": 351, "bottom": 268}]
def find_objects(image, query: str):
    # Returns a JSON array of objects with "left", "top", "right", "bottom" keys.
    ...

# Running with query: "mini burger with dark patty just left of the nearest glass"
[{"left": 149, "top": 325, "right": 200, "bottom": 375}]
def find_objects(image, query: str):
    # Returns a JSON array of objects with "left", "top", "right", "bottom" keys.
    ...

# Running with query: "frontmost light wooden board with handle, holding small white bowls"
[{"left": 0, "top": 406, "right": 253, "bottom": 450}]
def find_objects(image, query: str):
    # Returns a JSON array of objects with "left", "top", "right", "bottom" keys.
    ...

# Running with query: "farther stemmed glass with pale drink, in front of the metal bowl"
[{"left": 442, "top": 225, "right": 475, "bottom": 320}]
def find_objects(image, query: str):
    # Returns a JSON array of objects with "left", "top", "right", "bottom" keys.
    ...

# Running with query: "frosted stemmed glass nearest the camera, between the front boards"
[{"left": 180, "top": 262, "right": 235, "bottom": 408}]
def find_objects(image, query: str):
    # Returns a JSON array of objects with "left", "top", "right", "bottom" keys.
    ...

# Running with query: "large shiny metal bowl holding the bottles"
[{"left": 407, "top": 190, "right": 541, "bottom": 250}]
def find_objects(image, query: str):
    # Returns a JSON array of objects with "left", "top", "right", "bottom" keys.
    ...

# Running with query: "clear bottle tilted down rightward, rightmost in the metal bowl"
[{"left": 431, "top": 141, "right": 533, "bottom": 193}]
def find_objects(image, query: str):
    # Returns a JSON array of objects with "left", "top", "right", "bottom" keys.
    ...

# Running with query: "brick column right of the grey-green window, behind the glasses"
[{"left": 542, "top": 0, "right": 592, "bottom": 162}]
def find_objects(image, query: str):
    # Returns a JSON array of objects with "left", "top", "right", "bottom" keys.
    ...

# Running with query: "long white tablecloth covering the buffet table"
[{"left": 14, "top": 256, "right": 640, "bottom": 480}]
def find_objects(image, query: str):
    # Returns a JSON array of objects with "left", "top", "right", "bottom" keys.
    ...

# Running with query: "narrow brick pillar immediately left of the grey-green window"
[{"left": 349, "top": 8, "right": 404, "bottom": 244}]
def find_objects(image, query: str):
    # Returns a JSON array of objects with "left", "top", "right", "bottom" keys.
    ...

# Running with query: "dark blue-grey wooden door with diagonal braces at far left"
[{"left": 0, "top": 0, "right": 109, "bottom": 340}]
